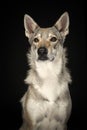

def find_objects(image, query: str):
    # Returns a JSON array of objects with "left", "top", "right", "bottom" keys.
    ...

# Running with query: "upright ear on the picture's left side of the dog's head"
[{"left": 24, "top": 14, "right": 38, "bottom": 38}]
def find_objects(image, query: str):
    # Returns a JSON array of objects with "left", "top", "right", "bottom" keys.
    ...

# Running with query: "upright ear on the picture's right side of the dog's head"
[{"left": 54, "top": 12, "right": 69, "bottom": 37}]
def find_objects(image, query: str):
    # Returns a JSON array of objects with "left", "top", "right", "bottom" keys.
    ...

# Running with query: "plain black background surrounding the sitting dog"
[{"left": 0, "top": 0, "right": 87, "bottom": 130}]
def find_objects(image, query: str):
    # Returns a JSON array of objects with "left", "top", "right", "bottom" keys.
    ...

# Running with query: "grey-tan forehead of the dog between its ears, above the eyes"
[{"left": 35, "top": 27, "right": 59, "bottom": 37}]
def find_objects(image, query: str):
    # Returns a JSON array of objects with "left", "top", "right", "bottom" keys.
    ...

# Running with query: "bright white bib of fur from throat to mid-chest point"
[{"left": 35, "top": 60, "right": 63, "bottom": 101}]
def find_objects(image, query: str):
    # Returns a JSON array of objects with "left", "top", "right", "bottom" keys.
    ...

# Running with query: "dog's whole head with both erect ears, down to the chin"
[{"left": 24, "top": 12, "right": 69, "bottom": 61}]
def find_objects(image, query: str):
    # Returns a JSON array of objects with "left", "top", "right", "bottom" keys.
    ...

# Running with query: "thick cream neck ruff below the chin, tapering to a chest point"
[{"left": 25, "top": 51, "right": 71, "bottom": 101}]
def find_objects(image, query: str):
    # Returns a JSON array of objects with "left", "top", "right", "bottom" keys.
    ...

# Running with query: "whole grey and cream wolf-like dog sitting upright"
[{"left": 20, "top": 12, "right": 72, "bottom": 130}]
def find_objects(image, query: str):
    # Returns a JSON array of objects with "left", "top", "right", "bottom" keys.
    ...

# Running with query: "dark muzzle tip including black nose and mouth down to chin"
[{"left": 37, "top": 47, "right": 48, "bottom": 60}]
